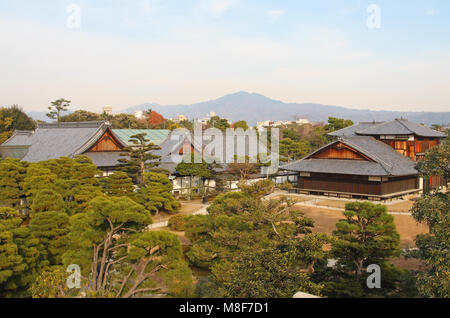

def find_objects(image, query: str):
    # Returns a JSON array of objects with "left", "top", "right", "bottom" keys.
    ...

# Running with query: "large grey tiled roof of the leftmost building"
[{"left": 0, "top": 122, "right": 125, "bottom": 162}]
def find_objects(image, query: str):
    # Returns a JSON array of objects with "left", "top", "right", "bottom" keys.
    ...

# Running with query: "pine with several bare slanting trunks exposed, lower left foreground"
[{"left": 63, "top": 197, "right": 152, "bottom": 292}]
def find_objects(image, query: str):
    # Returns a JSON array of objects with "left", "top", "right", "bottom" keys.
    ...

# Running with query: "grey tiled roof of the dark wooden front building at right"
[{"left": 280, "top": 136, "right": 417, "bottom": 176}]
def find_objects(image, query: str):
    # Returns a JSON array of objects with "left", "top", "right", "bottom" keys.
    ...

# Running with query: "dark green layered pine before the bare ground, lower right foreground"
[{"left": 315, "top": 202, "right": 407, "bottom": 297}]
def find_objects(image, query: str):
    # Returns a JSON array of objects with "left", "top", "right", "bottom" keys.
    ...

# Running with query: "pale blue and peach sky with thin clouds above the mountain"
[{"left": 0, "top": 0, "right": 450, "bottom": 111}]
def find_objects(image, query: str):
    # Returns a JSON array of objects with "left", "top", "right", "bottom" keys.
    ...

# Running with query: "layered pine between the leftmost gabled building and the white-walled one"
[{"left": 119, "top": 134, "right": 161, "bottom": 184}]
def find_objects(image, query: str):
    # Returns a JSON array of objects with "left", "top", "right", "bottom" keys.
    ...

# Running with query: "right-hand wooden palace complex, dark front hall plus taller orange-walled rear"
[{"left": 281, "top": 119, "right": 446, "bottom": 200}]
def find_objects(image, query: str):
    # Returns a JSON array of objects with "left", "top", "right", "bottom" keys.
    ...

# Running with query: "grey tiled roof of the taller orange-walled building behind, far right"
[{"left": 329, "top": 118, "right": 446, "bottom": 138}]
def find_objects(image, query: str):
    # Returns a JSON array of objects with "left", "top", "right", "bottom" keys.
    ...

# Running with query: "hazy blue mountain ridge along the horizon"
[{"left": 124, "top": 92, "right": 450, "bottom": 125}]
